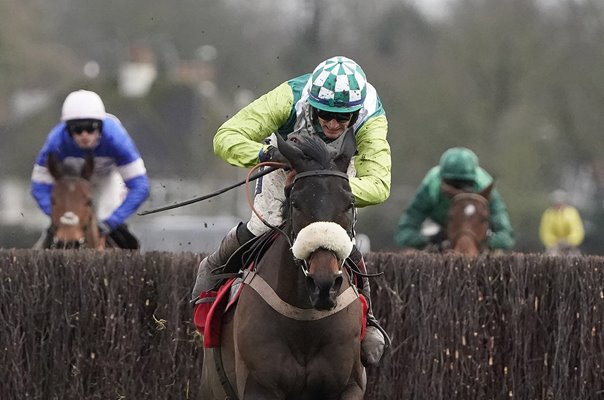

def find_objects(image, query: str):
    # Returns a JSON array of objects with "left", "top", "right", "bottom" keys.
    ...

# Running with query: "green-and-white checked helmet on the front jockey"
[{"left": 308, "top": 56, "right": 367, "bottom": 113}]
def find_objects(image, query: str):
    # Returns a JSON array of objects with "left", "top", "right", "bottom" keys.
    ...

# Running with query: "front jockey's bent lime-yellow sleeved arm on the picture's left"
[{"left": 213, "top": 82, "right": 294, "bottom": 168}]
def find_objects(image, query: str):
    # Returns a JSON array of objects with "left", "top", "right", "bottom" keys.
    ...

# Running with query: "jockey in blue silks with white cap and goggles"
[{"left": 31, "top": 90, "right": 149, "bottom": 249}]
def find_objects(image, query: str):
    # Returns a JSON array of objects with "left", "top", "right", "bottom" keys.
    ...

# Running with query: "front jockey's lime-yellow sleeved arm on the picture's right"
[{"left": 350, "top": 115, "right": 392, "bottom": 207}]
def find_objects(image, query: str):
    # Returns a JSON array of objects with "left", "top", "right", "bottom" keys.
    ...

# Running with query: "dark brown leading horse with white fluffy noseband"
[{"left": 201, "top": 130, "right": 367, "bottom": 400}]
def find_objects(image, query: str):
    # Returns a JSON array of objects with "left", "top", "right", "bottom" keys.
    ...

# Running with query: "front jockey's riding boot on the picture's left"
[{"left": 191, "top": 223, "right": 254, "bottom": 301}]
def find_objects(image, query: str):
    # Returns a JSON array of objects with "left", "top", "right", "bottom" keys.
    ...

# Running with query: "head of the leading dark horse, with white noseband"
[{"left": 279, "top": 132, "right": 356, "bottom": 310}]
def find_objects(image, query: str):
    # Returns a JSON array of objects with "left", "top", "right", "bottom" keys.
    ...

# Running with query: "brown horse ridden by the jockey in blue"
[{"left": 48, "top": 153, "right": 105, "bottom": 250}]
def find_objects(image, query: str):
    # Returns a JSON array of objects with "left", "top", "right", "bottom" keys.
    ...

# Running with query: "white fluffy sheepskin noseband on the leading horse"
[{"left": 292, "top": 222, "right": 353, "bottom": 260}]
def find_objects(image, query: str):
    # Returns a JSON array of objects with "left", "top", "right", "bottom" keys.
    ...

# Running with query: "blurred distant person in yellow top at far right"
[{"left": 539, "top": 189, "right": 585, "bottom": 253}]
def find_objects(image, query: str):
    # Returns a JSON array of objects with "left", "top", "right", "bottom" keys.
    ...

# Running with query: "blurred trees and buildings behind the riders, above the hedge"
[{"left": 0, "top": 0, "right": 604, "bottom": 254}]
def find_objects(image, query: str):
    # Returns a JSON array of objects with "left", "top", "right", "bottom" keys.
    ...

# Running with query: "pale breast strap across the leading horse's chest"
[{"left": 243, "top": 271, "right": 359, "bottom": 321}]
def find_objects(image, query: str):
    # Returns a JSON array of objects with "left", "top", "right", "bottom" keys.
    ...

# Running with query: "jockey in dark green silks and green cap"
[{"left": 394, "top": 147, "right": 515, "bottom": 250}]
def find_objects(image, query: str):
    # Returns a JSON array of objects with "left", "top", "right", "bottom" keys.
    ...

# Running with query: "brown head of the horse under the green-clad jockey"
[{"left": 442, "top": 182, "right": 494, "bottom": 256}]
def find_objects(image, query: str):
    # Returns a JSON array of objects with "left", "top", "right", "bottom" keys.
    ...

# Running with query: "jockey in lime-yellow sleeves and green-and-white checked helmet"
[{"left": 192, "top": 57, "right": 391, "bottom": 365}]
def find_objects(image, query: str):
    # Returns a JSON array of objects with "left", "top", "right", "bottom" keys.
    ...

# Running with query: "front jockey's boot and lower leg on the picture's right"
[{"left": 350, "top": 246, "right": 391, "bottom": 366}]
